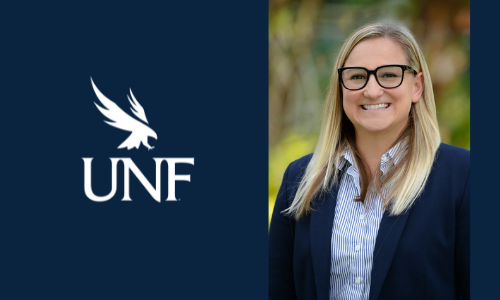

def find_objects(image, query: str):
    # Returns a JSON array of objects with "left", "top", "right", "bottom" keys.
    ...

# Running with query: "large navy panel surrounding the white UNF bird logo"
[{"left": 0, "top": 1, "right": 268, "bottom": 299}]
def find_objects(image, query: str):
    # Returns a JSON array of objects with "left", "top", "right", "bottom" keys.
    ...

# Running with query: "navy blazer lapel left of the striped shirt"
[{"left": 310, "top": 184, "right": 339, "bottom": 300}]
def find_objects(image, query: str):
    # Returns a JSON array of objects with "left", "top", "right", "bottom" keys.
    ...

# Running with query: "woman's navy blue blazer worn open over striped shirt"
[{"left": 269, "top": 144, "right": 470, "bottom": 300}]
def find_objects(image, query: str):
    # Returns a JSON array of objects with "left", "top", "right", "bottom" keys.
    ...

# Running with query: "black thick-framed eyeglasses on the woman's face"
[{"left": 338, "top": 65, "right": 417, "bottom": 90}]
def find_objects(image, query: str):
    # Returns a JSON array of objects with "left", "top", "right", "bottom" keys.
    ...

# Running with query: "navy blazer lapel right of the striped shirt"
[{"left": 370, "top": 208, "right": 411, "bottom": 300}]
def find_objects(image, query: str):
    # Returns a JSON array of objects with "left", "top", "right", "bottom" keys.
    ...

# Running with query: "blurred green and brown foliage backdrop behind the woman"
[{"left": 269, "top": 0, "right": 470, "bottom": 225}]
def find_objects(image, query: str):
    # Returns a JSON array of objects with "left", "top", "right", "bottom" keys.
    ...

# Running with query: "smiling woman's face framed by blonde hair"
[{"left": 342, "top": 38, "right": 423, "bottom": 137}]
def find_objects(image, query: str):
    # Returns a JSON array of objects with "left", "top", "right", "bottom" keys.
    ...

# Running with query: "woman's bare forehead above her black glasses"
[{"left": 344, "top": 38, "right": 408, "bottom": 69}]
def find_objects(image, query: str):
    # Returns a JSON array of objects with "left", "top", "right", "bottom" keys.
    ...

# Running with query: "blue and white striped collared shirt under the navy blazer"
[{"left": 330, "top": 144, "right": 399, "bottom": 300}]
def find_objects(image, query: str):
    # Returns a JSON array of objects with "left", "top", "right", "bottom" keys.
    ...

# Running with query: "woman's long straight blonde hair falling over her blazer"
[{"left": 284, "top": 21, "right": 441, "bottom": 219}]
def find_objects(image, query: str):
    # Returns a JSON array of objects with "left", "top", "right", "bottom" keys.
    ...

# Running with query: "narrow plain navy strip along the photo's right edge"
[{"left": 471, "top": 1, "right": 500, "bottom": 299}]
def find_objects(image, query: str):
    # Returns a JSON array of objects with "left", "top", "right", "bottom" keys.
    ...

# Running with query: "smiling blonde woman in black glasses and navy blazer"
[{"left": 269, "top": 22, "right": 470, "bottom": 300}]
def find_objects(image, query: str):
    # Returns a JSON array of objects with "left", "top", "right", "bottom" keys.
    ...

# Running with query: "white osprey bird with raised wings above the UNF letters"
[{"left": 90, "top": 77, "right": 158, "bottom": 150}]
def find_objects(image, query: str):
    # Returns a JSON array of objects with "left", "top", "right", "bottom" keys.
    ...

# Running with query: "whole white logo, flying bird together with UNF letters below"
[{"left": 82, "top": 78, "right": 194, "bottom": 202}]
